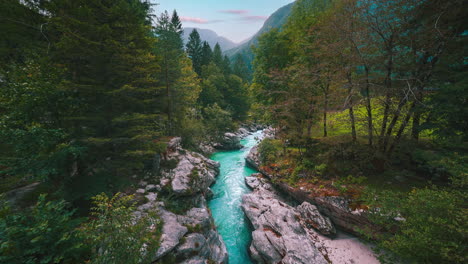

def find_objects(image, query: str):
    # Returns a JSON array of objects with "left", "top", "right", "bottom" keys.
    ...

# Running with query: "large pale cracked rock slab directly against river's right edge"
[{"left": 242, "top": 177, "right": 328, "bottom": 264}]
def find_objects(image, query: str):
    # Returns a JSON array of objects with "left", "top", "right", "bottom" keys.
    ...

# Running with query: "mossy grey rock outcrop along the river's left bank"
[{"left": 135, "top": 138, "right": 228, "bottom": 264}]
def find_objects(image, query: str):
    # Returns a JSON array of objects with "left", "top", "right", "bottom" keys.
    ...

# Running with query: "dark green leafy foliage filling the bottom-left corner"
[{"left": 0, "top": 195, "right": 88, "bottom": 264}]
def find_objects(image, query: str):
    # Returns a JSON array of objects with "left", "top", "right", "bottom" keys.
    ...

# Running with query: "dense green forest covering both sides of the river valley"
[{"left": 0, "top": 0, "right": 468, "bottom": 263}]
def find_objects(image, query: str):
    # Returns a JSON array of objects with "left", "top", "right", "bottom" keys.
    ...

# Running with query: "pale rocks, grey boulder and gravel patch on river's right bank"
[{"left": 242, "top": 174, "right": 379, "bottom": 264}]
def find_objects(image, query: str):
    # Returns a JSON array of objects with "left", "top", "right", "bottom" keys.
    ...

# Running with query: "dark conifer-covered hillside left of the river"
[{"left": 0, "top": 0, "right": 250, "bottom": 263}]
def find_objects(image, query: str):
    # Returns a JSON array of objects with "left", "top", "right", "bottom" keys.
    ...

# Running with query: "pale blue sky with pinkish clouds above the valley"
[{"left": 151, "top": 0, "right": 294, "bottom": 43}]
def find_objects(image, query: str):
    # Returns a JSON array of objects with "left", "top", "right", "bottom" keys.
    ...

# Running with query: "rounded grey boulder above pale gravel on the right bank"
[{"left": 296, "top": 202, "right": 336, "bottom": 235}]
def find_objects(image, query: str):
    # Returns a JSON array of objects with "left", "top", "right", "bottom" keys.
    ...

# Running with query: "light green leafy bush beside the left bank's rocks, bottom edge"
[{"left": 82, "top": 193, "right": 162, "bottom": 264}]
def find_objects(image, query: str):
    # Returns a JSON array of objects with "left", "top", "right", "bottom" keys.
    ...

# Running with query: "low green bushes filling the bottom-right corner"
[{"left": 366, "top": 188, "right": 468, "bottom": 263}]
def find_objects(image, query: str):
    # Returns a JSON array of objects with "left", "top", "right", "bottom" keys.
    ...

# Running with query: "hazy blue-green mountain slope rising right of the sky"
[{"left": 225, "top": 3, "right": 294, "bottom": 68}]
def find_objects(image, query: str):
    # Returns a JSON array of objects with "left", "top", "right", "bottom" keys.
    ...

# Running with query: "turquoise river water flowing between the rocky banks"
[{"left": 208, "top": 131, "right": 262, "bottom": 264}]
